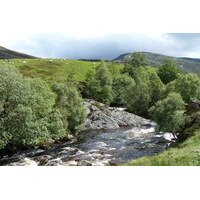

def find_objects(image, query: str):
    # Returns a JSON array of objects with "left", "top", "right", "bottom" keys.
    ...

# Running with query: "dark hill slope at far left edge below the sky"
[{"left": 0, "top": 46, "right": 37, "bottom": 59}]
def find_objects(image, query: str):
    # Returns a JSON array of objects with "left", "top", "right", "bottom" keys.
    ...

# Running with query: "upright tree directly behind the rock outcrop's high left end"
[{"left": 85, "top": 62, "right": 113, "bottom": 105}]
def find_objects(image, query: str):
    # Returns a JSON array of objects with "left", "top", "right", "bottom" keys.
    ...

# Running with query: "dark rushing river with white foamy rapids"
[{"left": 0, "top": 123, "right": 174, "bottom": 166}]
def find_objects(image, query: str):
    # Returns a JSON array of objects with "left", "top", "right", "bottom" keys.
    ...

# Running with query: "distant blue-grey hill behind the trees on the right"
[{"left": 113, "top": 52, "right": 200, "bottom": 74}]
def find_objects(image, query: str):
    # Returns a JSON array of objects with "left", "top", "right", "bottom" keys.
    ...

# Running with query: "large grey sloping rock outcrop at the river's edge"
[{"left": 84, "top": 99, "right": 150, "bottom": 130}]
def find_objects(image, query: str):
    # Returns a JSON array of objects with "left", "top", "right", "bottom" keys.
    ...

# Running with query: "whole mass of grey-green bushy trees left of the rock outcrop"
[{"left": 0, "top": 66, "right": 85, "bottom": 149}]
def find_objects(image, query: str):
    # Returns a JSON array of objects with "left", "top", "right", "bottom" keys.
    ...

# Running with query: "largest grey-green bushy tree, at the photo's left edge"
[{"left": 0, "top": 66, "right": 67, "bottom": 148}]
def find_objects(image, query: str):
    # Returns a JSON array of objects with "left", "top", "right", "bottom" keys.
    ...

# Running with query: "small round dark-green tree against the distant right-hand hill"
[{"left": 157, "top": 58, "right": 181, "bottom": 84}]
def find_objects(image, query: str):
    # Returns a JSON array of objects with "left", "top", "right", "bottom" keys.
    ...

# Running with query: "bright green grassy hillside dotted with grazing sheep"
[{"left": 0, "top": 59, "right": 123, "bottom": 83}]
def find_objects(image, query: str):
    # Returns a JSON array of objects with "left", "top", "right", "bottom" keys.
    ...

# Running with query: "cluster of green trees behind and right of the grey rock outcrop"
[{"left": 85, "top": 52, "right": 200, "bottom": 136}]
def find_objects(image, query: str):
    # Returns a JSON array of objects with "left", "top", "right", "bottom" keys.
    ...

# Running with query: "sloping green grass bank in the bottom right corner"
[{"left": 126, "top": 131, "right": 200, "bottom": 166}]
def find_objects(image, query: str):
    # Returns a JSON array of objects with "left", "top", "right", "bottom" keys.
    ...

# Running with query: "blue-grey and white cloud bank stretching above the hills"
[{"left": 12, "top": 33, "right": 200, "bottom": 59}]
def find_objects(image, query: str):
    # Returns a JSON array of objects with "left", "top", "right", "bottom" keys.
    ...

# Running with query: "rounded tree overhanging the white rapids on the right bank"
[{"left": 149, "top": 93, "right": 185, "bottom": 133}]
